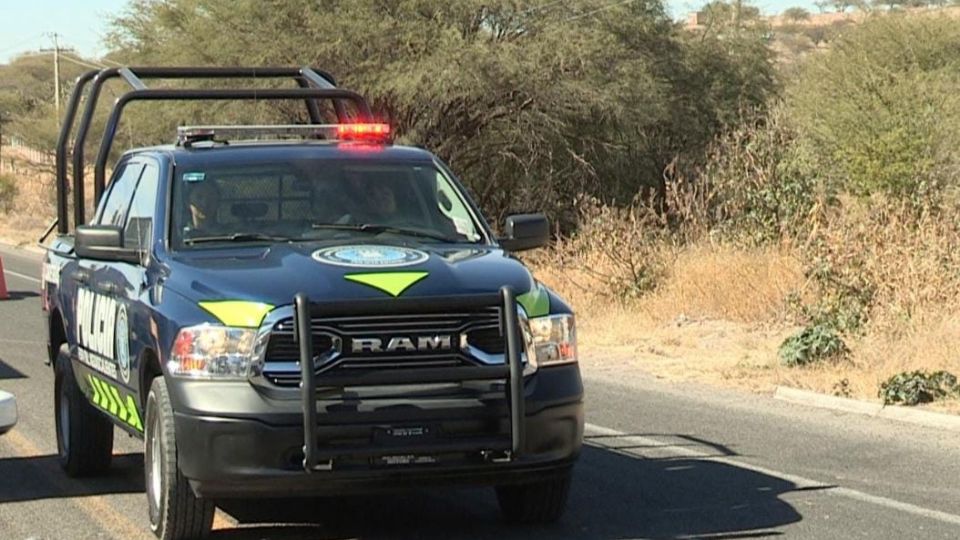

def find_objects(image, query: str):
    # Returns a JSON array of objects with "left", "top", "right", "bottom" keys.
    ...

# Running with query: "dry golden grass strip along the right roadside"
[{"left": 534, "top": 201, "right": 960, "bottom": 412}]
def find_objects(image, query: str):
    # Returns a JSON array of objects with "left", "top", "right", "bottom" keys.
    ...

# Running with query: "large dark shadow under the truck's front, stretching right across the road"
[{"left": 212, "top": 440, "right": 802, "bottom": 540}]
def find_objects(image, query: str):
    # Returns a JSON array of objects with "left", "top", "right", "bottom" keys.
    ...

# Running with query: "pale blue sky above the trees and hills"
[{"left": 0, "top": 0, "right": 816, "bottom": 63}]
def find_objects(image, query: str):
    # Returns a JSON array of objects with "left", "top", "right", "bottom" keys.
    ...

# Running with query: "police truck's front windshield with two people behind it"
[{"left": 171, "top": 159, "right": 483, "bottom": 247}]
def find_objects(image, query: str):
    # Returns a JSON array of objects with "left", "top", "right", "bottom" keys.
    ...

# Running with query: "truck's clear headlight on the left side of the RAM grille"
[{"left": 167, "top": 324, "right": 257, "bottom": 379}]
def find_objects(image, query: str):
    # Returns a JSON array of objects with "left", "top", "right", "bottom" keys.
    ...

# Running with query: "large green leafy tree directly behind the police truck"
[{"left": 103, "top": 0, "right": 775, "bottom": 224}]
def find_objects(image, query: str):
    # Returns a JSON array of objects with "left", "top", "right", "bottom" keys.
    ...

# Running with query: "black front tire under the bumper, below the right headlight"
[{"left": 496, "top": 470, "right": 572, "bottom": 524}]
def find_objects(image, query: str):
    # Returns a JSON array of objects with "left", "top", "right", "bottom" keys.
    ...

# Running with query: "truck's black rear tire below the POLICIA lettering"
[{"left": 53, "top": 346, "right": 113, "bottom": 477}]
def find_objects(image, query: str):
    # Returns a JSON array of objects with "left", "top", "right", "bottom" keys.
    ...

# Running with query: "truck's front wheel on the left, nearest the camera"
[{"left": 143, "top": 376, "right": 216, "bottom": 540}]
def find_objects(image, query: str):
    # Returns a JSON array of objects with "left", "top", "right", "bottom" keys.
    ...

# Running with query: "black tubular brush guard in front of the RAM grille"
[{"left": 294, "top": 287, "right": 526, "bottom": 472}]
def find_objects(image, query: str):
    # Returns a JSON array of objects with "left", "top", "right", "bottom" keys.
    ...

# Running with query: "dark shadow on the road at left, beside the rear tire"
[{"left": 0, "top": 454, "right": 143, "bottom": 504}]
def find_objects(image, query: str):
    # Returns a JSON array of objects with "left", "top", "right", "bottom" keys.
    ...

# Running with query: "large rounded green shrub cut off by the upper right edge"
[{"left": 786, "top": 14, "right": 960, "bottom": 197}]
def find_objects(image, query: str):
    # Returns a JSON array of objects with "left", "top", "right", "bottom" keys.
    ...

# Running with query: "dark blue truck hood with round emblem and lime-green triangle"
[{"left": 164, "top": 243, "right": 534, "bottom": 306}]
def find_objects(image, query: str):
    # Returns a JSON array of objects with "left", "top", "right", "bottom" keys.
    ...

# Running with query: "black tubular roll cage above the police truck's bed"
[{"left": 56, "top": 67, "right": 373, "bottom": 234}]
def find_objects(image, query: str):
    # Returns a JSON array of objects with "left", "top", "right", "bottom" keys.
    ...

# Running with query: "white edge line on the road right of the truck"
[{"left": 585, "top": 423, "right": 960, "bottom": 526}]
